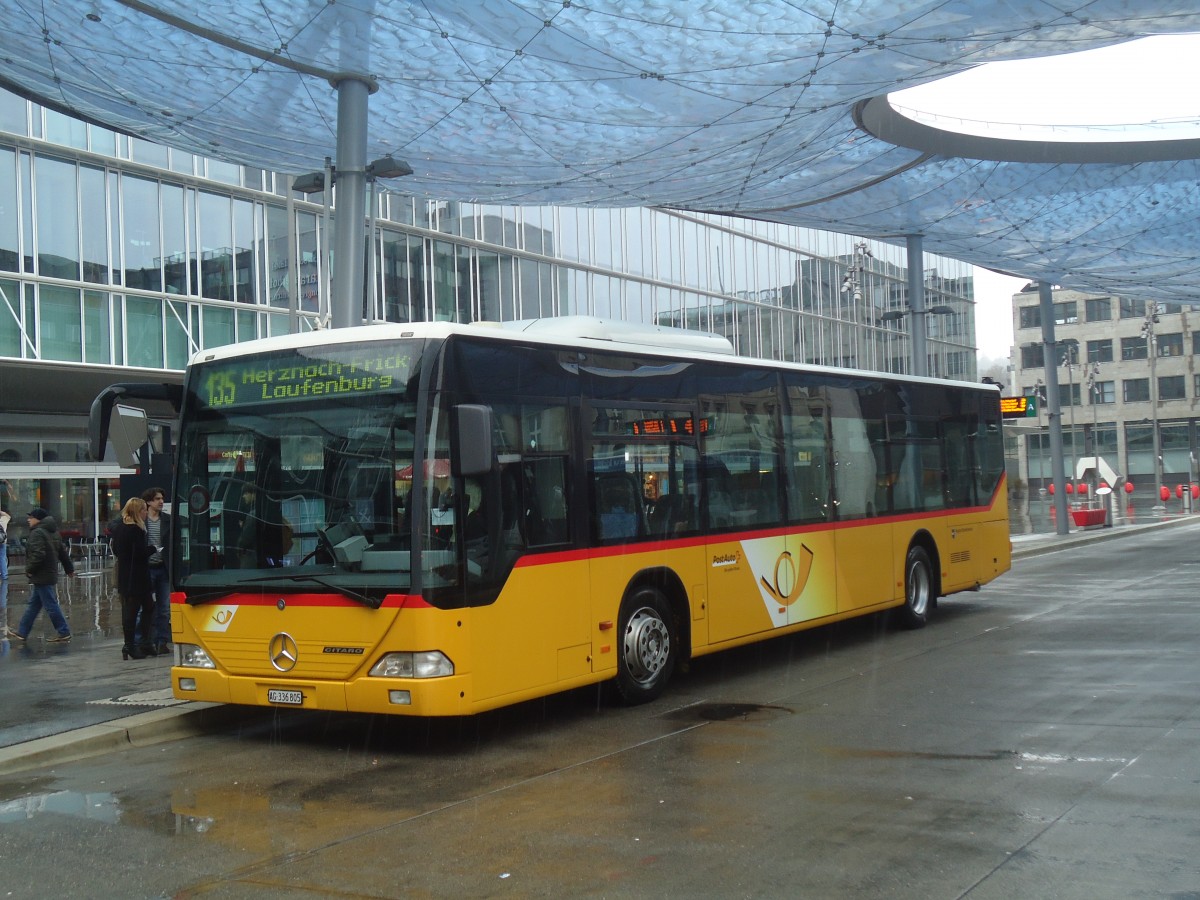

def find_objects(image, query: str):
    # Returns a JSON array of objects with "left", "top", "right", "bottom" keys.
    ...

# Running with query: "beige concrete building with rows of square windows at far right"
[{"left": 1013, "top": 284, "right": 1200, "bottom": 498}]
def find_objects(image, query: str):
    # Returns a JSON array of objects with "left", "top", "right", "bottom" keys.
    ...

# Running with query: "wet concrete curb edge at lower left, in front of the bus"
[{"left": 0, "top": 702, "right": 244, "bottom": 775}]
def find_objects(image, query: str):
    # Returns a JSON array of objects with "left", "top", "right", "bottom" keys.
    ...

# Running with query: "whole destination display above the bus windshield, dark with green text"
[{"left": 192, "top": 343, "right": 416, "bottom": 409}]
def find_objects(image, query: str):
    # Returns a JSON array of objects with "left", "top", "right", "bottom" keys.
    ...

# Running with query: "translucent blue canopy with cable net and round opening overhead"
[{"left": 0, "top": 0, "right": 1200, "bottom": 304}]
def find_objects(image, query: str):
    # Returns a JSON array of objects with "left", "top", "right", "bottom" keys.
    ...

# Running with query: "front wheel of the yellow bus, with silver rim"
[{"left": 616, "top": 587, "right": 679, "bottom": 704}]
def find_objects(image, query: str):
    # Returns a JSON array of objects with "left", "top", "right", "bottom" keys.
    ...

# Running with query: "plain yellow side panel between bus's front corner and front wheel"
[{"left": 470, "top": 554, "right": 592, "bottom": 702}]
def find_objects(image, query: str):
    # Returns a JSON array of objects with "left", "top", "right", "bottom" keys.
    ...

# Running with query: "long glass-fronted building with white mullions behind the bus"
[{"left": 0, "top": 91, "right": 976, "bottom": 547}]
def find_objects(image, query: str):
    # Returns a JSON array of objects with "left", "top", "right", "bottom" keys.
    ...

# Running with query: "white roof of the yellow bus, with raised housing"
[{"left": 188, "top": 316, "right": 1000, "bottom": 394}]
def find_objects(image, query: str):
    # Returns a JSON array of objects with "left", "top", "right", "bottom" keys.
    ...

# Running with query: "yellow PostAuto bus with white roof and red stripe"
[{"left": 94, "top": 317, "right": 1010, "bottom": 716}]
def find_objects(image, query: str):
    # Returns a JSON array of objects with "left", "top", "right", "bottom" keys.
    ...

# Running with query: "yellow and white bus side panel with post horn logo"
[{"left": 708, "top": 532, "right": 838, "bottom": 643}]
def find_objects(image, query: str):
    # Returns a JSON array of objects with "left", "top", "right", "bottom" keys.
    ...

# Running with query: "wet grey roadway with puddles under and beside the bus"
[{"left": 0, "top": 517, "right": 1200, "bottom": 900}]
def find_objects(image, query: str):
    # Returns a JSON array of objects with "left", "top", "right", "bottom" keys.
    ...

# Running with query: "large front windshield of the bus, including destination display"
[{"left": 174, "top": 342, "right": 420, "bottom": 606}]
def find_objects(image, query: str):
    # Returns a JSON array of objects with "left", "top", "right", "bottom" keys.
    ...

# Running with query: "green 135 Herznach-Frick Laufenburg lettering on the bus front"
[{"left": 200, "top": 353, "right": 412, "bottom": 408}]
